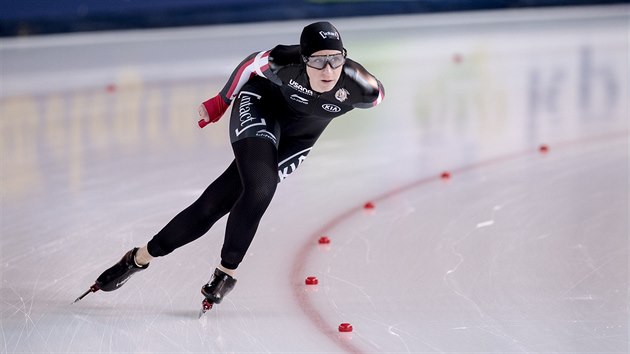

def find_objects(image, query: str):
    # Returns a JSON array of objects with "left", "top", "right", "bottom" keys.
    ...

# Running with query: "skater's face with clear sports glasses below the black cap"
[{"left": 306, "top": 49, "right": 345, "bottom": 93}]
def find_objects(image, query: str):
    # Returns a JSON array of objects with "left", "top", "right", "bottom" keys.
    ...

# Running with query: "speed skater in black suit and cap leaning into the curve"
[{"left": 75, "top": 22, "right": 384, "bottom": 310}]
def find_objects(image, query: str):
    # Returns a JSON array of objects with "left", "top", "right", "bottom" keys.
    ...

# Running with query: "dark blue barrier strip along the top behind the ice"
[{"left": 0, "top": 0, "right": 628, "bottom": 36}]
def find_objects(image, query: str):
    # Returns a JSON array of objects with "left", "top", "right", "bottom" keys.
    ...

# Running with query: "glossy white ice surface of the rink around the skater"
[{"left": 0, "top": 6, "right": 628, "bottom": 353}]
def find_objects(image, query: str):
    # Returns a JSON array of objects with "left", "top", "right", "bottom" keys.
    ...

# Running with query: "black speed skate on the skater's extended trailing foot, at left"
[{"left": 74, "top": 248, "right": 149, "bottom": 302}]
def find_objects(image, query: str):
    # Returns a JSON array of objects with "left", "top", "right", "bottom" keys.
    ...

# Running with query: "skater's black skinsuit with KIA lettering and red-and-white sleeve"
[{"left": 148, "top": 45, "right": 384, "bottom": 269}]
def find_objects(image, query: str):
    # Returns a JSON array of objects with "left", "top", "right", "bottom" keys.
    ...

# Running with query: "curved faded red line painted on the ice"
[{"left": 291, "top": 130, "right": 630, "bottom": 354}]
